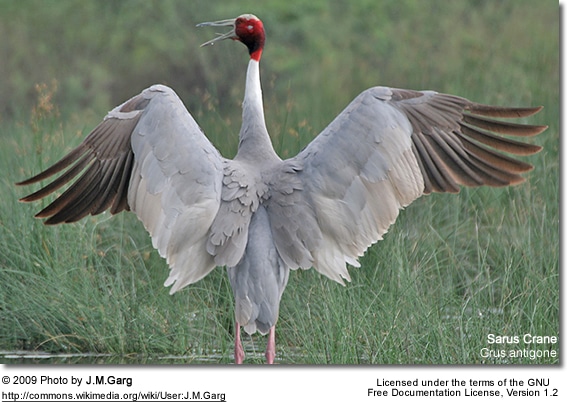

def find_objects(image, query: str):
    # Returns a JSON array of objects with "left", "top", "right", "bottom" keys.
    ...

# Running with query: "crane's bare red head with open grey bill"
[{"left": 197, "top": 14, "right": 266, "bottom": 61}]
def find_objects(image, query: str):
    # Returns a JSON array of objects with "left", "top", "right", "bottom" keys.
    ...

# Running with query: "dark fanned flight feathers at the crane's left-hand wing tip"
[{"left": 16, "top": 110, "right": 141, "bottom": 225}]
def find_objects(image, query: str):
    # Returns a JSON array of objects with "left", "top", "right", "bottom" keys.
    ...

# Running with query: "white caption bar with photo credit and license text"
[{"left": 0, "top": 366, "right": 565, "bottom": 402}]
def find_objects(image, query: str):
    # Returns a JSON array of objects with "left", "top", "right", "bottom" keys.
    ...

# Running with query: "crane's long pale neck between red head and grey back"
[{"left": 236, "top": 58, "right": 279, "bottom": 161}]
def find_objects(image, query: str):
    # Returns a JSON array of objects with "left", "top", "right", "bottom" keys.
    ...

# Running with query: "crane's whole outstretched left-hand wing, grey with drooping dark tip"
[{"left": 18, "top": 85, "right": 223, "bottom": 293}]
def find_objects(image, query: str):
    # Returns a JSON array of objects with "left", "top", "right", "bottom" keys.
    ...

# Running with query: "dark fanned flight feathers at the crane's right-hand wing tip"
[{"left": 395, "top": 92, "right": 548, "bottom": 193}]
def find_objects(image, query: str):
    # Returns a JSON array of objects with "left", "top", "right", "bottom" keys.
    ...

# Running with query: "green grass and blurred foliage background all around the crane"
[{"left": 0, "top": 0, "right": 559, "bottom": 364}]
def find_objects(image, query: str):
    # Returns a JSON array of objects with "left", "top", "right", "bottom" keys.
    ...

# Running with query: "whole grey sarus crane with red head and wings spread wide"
[{"left": 18, "top": 14, "right": 547, "bottom": 363}]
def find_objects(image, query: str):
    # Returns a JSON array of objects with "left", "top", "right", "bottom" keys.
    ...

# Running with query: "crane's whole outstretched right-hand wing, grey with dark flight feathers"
[{"left": 270, "top": 87, "right": 546, "bottom": 283}]
